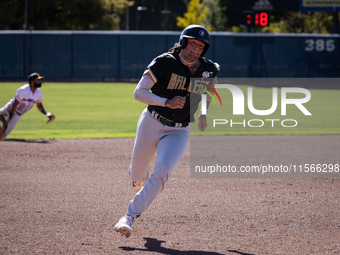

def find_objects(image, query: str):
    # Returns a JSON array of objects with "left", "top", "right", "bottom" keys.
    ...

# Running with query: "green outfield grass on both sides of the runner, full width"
[{"left": 0, "top": 82, "right": 340, "bottom": 140}]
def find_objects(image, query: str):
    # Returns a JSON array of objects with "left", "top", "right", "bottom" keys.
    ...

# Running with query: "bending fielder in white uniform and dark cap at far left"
[{"left": 0, "top": 73, "right": 55, "bottom": 141}]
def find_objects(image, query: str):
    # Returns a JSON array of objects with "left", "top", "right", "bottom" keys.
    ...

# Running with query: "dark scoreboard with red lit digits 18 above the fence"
[{"left": 227, "top": 0, "right": 299, "bottom": 27}]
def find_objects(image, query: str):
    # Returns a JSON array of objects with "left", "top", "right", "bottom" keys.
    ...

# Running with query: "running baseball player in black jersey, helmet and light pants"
[{"left": 114, "top": 25, "right": 219, "bottom": 237}]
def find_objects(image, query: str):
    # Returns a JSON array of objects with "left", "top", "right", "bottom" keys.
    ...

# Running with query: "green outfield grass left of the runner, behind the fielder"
[{"left": 0, "top": 82, "right": 145, "bottom": 139}]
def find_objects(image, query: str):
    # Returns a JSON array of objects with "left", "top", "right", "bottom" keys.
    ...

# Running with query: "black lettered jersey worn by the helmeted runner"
[{"left": 144, "top": 53, "right": 219, "bottom": 123}]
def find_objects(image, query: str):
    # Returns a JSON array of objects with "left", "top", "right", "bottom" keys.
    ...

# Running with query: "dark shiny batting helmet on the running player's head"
[{"left": 178, "top": 25, "right": 210, "bottom": 57}]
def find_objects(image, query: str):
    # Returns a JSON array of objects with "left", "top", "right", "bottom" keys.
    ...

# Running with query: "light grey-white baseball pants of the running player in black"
[{"left": 127, "top": 109, "right": 190, "bottom": 218}]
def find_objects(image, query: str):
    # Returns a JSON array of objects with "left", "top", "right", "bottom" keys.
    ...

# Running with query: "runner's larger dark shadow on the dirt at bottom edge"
[{"left": 119, "top": 238, "right": 226, "bottom": 255}]
